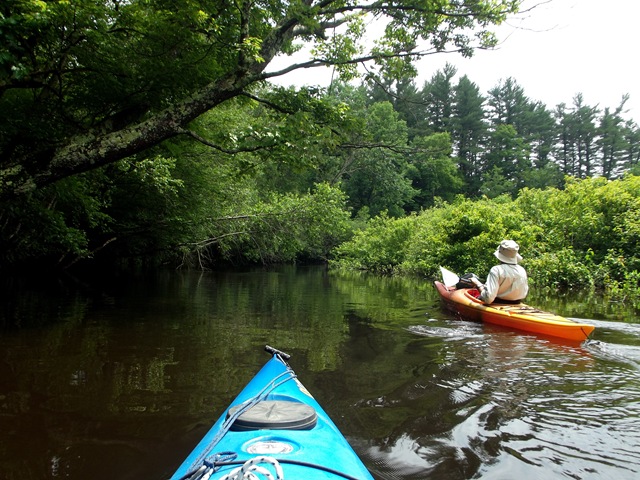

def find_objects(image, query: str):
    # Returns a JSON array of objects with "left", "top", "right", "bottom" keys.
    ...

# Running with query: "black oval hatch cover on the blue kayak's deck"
[{"left": 227, "top": 400, "right": 318, "bottom": 431}]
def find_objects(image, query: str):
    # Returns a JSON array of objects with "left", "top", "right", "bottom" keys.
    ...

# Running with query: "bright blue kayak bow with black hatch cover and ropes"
[{"left": 171, "top": 346, "right": 373, "bottom": 480}]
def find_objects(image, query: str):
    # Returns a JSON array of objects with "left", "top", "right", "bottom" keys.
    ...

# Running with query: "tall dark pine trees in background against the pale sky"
[{"left": 370, "top": 71, "right": 640, "bottom": 195}]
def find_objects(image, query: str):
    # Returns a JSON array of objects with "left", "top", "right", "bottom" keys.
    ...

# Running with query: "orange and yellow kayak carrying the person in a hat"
[{"left": 435, "top": 282, "right": 595, "bottom": 341}]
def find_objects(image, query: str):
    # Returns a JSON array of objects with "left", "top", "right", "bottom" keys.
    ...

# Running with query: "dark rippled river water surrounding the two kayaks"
[{"left": 0, "top": 267, "right": 640, "bottom": 480}]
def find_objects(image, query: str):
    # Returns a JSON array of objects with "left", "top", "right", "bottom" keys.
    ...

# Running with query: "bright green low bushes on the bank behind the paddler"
[{"left": 332, "top": 175, "right": 640, "bottom": 296}]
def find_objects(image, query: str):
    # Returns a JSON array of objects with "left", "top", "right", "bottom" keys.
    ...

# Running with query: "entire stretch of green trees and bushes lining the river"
[{"left": 0, "top": 0, "right": 640, "bottom": 297}]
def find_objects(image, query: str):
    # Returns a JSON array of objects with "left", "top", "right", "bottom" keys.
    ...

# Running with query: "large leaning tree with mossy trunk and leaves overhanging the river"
[{"left": 0, "top": 0, "right": 520, "bottom": 200}]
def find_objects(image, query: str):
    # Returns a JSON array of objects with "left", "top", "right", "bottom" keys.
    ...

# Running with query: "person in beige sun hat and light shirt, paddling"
[{"left": 478, "top": 240, "right": 529, "bottom": 303}]
